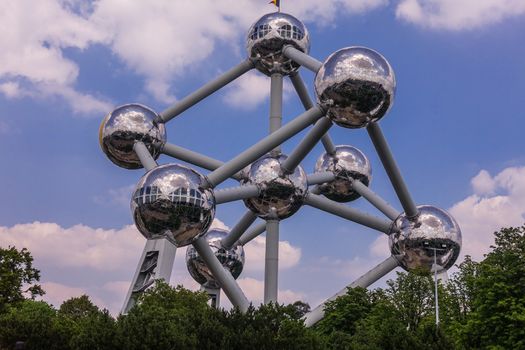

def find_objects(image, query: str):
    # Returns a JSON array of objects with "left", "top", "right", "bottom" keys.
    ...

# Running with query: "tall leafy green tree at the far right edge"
[{"left": 459, "top": 226, "right": 525, "bottom": 349}]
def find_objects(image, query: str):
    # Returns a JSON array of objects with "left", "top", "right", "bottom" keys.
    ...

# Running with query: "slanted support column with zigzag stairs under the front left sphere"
[{"left": 120, "top": 238, "right": 177, "bottom": 314}]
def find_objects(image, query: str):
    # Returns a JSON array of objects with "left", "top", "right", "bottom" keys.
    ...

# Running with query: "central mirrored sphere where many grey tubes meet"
[{"left": 243, "top": 155, "right": 308, "bottom": 219}]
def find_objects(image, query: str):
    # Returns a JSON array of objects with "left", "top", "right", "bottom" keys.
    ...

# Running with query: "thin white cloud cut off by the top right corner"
[{"left": 396, "top": 0, "right": 525, "bottom": 30}]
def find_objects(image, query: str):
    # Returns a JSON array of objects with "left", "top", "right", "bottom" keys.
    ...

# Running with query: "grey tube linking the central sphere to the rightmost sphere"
[{"left": 304, "top": 193, "right": 392, "bottom": 234}]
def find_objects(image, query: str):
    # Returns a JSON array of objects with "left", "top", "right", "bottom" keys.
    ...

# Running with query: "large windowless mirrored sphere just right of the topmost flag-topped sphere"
[{"left": 314, "top": 47, "right": 396, "bottom": 128}]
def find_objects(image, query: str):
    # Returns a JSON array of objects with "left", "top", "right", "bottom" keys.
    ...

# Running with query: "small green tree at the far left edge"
[{"left": 0, "top": 247, "right": 44, "bottom": 313}]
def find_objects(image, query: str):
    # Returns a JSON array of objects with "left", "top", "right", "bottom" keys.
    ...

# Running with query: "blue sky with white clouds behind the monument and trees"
[{"left": 0, "top": 0, "right": 525, "bottom": 312}]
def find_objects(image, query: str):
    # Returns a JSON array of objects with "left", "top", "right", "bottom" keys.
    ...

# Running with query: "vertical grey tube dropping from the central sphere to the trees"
[{"left": 264, "top": 218, "right": 279, "bottom": 304}]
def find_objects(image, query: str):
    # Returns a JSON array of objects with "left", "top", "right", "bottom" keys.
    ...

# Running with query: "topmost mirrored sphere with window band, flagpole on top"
[{"left": 246, "top": 12, "right": 310, "bottom": 75}]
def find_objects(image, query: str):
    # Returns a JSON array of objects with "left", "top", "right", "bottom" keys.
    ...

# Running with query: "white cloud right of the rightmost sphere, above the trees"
[{"left": 449, "top": 167, "right": 525, "bottom": 262}]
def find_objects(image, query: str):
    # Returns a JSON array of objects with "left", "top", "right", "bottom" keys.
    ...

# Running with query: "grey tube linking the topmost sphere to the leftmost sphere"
[{"left": 160, "top": 59, "right": 254, "bottom": 123}]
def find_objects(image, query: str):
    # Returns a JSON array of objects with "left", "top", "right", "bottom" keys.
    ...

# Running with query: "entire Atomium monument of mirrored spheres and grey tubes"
[{"left": 99, "top": 12, "right": 461, "bottom": 325}]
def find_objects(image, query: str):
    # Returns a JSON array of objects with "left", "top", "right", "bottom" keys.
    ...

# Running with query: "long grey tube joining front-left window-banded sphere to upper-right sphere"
[{"left": 208, "top": 107, "right": 324, "bottom": 187}]
